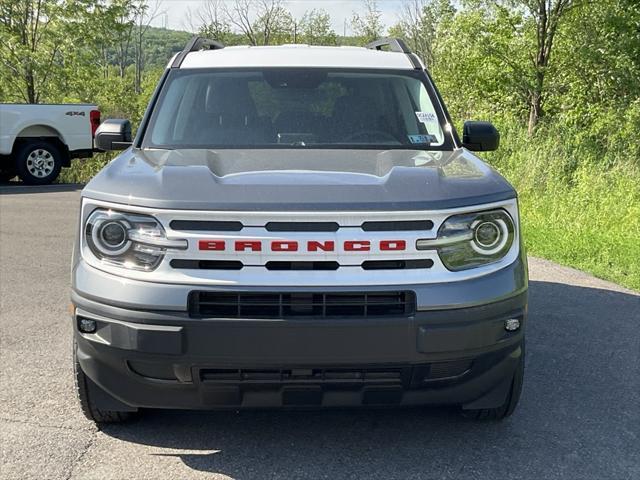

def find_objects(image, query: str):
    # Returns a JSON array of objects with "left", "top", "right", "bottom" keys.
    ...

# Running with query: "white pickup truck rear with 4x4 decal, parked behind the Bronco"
[{"left": 0, "top": 104, "right": 100, "bottom": 185}]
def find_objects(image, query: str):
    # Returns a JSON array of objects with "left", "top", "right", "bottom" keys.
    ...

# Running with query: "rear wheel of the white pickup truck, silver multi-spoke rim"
[{"left": 15, "top": 140, "right": 64, "bottom": 185}]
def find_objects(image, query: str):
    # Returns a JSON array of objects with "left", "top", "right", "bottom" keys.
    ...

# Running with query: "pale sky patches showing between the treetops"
[{"left": 150, "top": 0, "right": 403, "bottom": 35}]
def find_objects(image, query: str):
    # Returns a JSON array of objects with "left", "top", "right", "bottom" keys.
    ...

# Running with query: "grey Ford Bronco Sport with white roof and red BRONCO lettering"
[{"left": 72, "top": 38, "right": 527, "bottom": 422}]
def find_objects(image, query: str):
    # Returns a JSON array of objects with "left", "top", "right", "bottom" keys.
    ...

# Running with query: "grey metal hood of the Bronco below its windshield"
[{"left": 83, "top": 149, "right": 516, "bottom": 211}]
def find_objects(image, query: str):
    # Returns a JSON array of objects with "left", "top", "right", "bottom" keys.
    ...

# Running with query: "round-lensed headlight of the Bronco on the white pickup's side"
[{"left": 84, "top": 209, "right": 187, "bottom": 271}]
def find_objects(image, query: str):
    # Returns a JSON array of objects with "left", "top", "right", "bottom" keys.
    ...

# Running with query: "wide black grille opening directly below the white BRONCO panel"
[{"left": 189, "top": 291, "right": 416, "bottom": 318}]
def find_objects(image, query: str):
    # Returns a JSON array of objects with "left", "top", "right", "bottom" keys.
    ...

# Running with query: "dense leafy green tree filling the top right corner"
[{"left": 545, "top": 0, "right": 640, "bottom": 165}]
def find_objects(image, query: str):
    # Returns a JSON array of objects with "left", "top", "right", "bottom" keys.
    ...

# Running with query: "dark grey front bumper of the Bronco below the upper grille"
[{"left": 73, "top": 266, "right": 527, "bottom": 409}]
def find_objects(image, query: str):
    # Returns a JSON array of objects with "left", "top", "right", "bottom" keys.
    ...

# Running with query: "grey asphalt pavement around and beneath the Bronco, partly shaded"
[{"left": 0, "top": 189, "right": 640, "bottom": 480}]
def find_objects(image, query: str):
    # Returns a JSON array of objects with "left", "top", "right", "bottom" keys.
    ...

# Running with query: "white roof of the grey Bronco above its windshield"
[{"left": 176, "top": 45, "right": 413, "bottom": 69}]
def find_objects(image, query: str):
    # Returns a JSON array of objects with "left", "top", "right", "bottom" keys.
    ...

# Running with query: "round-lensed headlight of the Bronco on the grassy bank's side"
[{"left": 416, "top": 210, "right": 515, "bottom": 271}]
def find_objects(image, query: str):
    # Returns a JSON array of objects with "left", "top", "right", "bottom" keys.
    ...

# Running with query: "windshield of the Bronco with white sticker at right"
[{"left": 143, "top": 68, "right": 450, "bottom": 150}]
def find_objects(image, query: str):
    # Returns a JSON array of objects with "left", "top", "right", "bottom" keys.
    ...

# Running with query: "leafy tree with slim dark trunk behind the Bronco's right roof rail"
[{"left": 420, "top": 0, "right": 577, "bottom": 134}]
